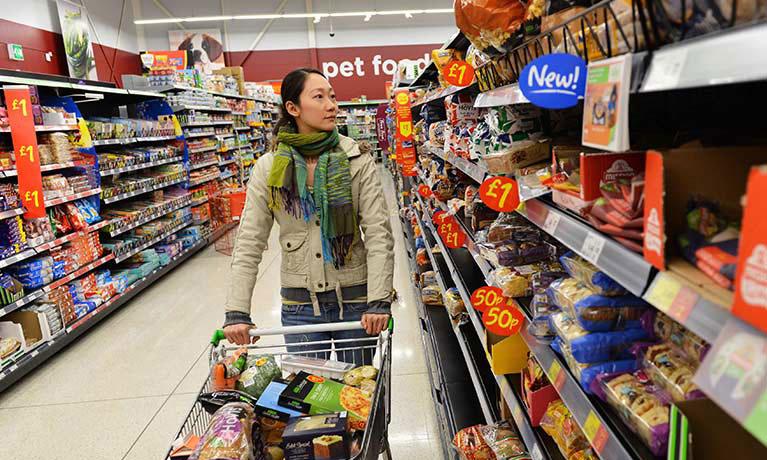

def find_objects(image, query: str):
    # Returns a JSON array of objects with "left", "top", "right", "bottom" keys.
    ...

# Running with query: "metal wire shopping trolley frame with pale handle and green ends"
[{"left": 165, "top": 320, "right": 394, "bottom": 460}]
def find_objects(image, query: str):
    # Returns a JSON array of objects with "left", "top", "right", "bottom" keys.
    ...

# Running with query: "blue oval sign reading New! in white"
[{"left": 519, "top": 53, "right": 586, "bottom": 109}]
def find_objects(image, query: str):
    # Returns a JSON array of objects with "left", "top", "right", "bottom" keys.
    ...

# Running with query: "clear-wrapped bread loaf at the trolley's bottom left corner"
[{"left": 189, "top": 402, "right": 261, "bottom": 460}]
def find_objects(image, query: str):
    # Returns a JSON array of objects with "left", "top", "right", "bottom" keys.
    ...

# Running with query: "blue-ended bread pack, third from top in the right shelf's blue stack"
[{"left": 550, "top": 313, "right": 648, "bottom": 363}]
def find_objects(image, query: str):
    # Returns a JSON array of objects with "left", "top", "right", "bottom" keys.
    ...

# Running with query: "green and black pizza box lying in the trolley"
[{"left": 278, "top": 371, "right": 371, "bottom": 430}]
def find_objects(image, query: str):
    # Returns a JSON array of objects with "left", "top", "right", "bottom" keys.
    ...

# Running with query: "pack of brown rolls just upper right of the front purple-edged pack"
[{"left": 642, "top": 344, "right": 704, "bottom": 402}]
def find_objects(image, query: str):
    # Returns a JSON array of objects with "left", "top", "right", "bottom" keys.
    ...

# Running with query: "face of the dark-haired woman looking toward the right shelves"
[{"left": 285, "top": 73, "right": 338, "bottom": 133}]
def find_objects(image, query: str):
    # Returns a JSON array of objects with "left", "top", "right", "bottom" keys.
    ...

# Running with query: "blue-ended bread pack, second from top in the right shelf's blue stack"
[{"left": 547, "top": 278, "right": 648, "bottom": 332}]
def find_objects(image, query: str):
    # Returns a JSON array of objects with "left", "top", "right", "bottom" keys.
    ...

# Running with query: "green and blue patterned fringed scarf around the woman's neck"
[{"left": 266, "top": 128, "right": 357, "bottom": 269}]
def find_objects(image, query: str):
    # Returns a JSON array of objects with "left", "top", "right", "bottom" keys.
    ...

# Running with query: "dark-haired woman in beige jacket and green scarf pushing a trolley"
[{"left": 224, "top": 69, "right": 394, "bottom": 363}]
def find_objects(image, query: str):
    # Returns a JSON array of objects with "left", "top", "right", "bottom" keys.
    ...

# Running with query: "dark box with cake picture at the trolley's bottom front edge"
[{"left": 282, "top": 412, "right": 349, "bottom": 460}]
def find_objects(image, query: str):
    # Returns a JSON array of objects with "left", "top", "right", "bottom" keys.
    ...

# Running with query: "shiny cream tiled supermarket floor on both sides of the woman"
[{"left": 0, "top": 166, "right": 442, "bottom": 460}]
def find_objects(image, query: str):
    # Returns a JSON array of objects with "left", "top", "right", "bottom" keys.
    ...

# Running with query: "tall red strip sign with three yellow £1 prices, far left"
[{"left": 4, "top": 86, "right": 45, "bottom": 218}]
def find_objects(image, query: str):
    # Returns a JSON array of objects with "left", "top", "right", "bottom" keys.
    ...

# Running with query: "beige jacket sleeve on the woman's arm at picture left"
[{"left": 226, "top": 155, "right": 274, "bottom": 322}]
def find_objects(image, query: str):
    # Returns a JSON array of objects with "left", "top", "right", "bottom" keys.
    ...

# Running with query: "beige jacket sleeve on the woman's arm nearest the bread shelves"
[{"left": 359, "top": 155, "right": 394, "bottom": 303}]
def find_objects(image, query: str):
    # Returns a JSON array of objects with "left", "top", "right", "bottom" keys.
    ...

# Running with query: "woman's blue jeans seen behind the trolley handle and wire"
[{"left": 282, "top": 302, "right": 376, "bottom": 366}]
